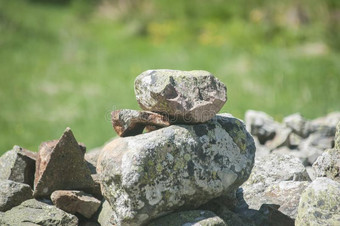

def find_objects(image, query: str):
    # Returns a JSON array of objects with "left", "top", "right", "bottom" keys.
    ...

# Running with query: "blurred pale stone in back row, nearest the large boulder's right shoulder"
[{"left": 245, "top": 110, "right": 281, "bottom": 144}]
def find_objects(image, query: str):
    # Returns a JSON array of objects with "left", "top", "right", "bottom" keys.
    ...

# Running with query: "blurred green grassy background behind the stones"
[{"left": 0, "top": 0, "right": 340, "bottom": 154}]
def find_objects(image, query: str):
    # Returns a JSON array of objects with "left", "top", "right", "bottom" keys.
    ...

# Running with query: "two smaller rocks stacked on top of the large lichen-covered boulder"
[{"left": 112, "top": 70, "right": 227, "bottom": 137}]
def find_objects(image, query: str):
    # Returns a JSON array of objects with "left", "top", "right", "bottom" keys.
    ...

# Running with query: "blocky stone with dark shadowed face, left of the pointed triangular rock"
[{"left": 0, "top": 145, "right": 37, "bottom": 187}]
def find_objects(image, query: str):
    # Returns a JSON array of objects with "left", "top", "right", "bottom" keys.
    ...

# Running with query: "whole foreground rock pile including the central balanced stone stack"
[{"left": 0, "top": 70, "right": 340, "bottom": 226}]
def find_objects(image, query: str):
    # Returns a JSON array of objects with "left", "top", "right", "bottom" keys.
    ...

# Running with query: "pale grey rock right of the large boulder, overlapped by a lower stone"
[{"left": 238, "top": 153, "right": 310, "bottom": 209}]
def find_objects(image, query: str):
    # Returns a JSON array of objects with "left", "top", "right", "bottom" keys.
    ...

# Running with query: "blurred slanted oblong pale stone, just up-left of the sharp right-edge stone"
[{"left": 298, "top": 127, "right": 335, "bottom": 165}]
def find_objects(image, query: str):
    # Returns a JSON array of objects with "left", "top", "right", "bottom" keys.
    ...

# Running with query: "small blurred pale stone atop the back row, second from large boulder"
[{"left": 283, "top": 113, "right": 312, "bottom": 138}]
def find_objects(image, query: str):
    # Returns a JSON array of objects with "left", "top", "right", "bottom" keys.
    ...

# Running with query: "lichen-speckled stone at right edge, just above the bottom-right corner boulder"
[{"left": 313, "top": 149, "right": 340, "bottom": 183}]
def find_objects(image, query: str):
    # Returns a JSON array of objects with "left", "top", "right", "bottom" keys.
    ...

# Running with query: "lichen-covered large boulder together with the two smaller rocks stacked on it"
[{"left": 101, "top": 70, "right": 255, "bottom": 225}]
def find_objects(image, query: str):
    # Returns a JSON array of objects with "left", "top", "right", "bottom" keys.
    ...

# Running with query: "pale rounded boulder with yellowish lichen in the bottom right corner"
[{"left": 296, "top": 177, "right": 340, "bottom": 226}]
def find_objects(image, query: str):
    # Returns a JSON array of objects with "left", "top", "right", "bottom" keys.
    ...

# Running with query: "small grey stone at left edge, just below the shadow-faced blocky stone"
[{"left": 0, "top": 180, "right": 33, "bottom": 211}]
